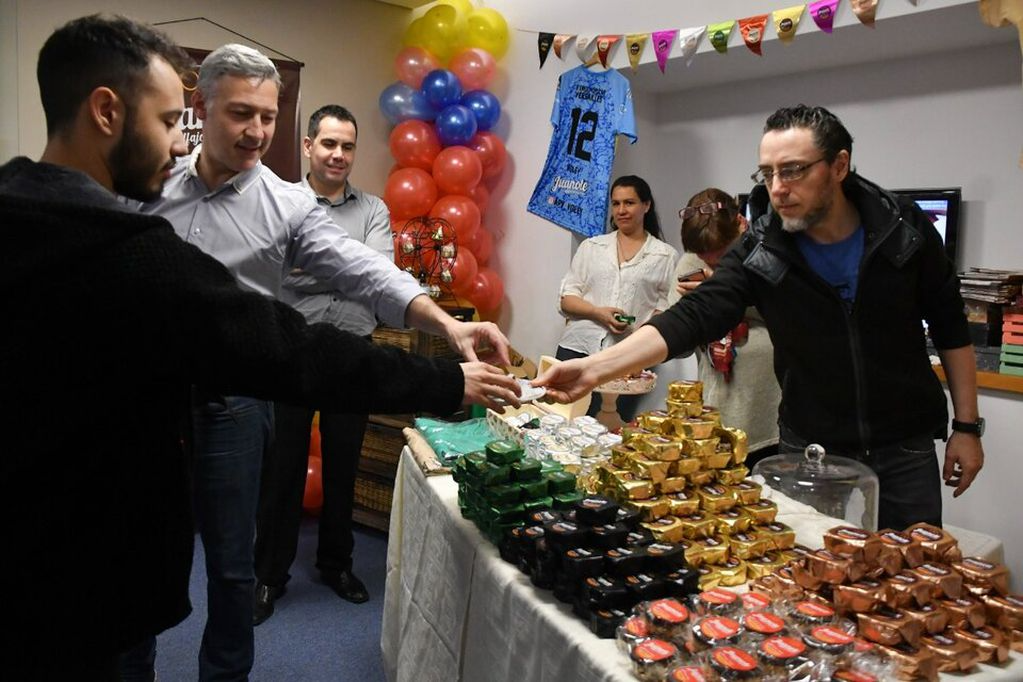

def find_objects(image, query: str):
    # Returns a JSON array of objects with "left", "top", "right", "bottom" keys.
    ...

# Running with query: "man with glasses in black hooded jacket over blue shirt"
[{"left": 535, "top": 105, "right": 984, "bottom": 529}]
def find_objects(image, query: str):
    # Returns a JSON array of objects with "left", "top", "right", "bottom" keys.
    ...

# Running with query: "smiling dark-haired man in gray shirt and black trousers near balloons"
[{"left": 253, "top": 104, "right": 394, "bottom": 625}]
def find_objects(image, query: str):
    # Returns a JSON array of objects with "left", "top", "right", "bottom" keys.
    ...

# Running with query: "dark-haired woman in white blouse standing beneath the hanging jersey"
[{"left": 557, "top": 175, "right": 678, "bottom": 421}]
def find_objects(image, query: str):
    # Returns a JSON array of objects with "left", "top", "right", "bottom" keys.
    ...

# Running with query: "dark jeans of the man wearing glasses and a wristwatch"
[{"left": 779, "top": 424, "right": 941, "bottom": 531}]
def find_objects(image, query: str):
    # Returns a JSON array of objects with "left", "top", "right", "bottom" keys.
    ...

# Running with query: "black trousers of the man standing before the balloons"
[{"left": 256, "top": 403, "right": 368, "bottom": 586}]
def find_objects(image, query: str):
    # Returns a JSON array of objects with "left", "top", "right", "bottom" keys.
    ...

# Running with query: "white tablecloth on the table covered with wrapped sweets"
[{"left": 381, "top": 448, "right": 1023, "bottom": 682}]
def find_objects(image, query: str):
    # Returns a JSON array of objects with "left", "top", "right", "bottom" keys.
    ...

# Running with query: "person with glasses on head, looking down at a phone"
[{"left": 668, "top": 187, "right": 782, "bottom": 468}]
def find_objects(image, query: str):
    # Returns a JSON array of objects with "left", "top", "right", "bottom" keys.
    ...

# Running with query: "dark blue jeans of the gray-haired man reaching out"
[{"left": 192, "top": 396, "right": 273, "bottom": 680}]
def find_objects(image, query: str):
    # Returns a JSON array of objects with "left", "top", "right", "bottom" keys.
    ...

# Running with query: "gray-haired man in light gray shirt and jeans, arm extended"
[{"left": 136, "top": 45, "right": 518, "bottom": 680}]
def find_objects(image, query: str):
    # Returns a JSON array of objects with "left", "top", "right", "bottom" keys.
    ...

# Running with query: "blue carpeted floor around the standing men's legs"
[{"left": 157, "top": 519, "right": 387, "bottom": 682}]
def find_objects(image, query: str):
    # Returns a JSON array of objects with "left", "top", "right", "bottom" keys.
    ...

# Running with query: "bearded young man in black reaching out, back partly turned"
[{"left": 0, "top": 16, "right": 518, "bottom": 680}]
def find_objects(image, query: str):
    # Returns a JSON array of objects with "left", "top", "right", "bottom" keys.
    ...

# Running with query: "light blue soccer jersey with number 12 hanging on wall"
[{"left": 527, "top": 66, "right": 636, "bottom": 237}]
